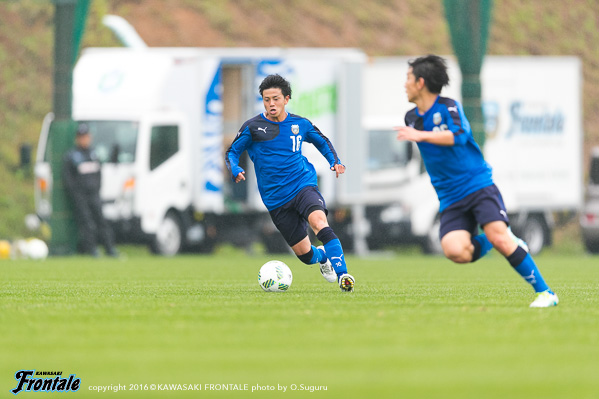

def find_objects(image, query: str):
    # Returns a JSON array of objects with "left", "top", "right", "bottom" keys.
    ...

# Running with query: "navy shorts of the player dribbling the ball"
[{"left": 269, "top": 186, "right": 329, "bottom": 247}]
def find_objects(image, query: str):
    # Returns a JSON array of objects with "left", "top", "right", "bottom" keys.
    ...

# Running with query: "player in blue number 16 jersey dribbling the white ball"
[{"left": 226, "top": 75, "right": 355, "bottom": 291}]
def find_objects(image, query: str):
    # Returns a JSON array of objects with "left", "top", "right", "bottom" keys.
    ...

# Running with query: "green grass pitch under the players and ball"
[{"left": 0, "top": 251, "right": 599, "bottom": 399}]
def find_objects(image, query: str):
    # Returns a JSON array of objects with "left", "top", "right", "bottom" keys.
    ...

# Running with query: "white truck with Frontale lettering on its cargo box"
[{"left": 353, "top": 56, "right": 583, "bottom": 253}]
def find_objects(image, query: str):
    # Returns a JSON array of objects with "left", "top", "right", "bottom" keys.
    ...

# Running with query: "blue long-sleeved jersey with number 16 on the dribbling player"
[{"left": 226, "top": 114, "right": 340, "bottom": 211}]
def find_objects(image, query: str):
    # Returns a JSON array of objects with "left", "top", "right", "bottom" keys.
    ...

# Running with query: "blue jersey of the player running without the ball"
[{"left": 405, "top": 96, "right": 493, "bottom": 212}]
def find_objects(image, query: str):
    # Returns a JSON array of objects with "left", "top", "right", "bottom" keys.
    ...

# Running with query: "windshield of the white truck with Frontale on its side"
[{"left": 368, "top": 130, "right": 411, "bottom": 171}]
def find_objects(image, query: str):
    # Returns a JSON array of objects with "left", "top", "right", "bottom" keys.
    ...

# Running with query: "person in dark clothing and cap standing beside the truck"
[{"left": 63, "top": 123, "right": 118, "bottom": 257}]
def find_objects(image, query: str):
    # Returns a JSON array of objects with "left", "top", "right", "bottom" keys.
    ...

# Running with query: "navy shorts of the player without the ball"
[{"left": 439, "top": 184, "right": 510, "bottom": 238}]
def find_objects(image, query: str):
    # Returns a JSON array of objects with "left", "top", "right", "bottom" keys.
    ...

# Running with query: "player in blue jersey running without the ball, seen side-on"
[{"left": 394, "top": 55, "right": 559, "bottom": 308}]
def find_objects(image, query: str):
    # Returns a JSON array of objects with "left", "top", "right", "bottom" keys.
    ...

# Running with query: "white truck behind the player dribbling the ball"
[{"left": 35, "top": 47, "right": 366, "bottom": 255}]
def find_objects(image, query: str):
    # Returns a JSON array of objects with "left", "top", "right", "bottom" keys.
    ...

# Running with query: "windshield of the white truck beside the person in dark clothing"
[{"left": 85, "top": 121, "right": 139, "bottom": 163}]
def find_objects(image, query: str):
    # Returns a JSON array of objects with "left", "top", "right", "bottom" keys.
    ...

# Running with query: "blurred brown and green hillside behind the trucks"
[{"left": 0, "top": 0, "right": 599, "bottom": 238}]
